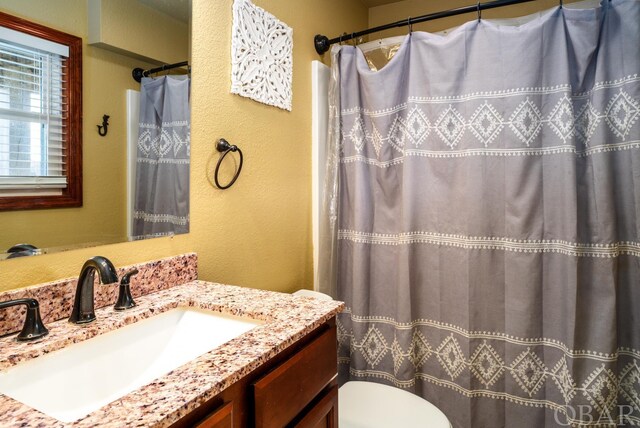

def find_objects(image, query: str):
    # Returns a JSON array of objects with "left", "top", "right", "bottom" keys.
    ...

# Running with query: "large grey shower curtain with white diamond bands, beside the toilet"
[{"left": 321, "top": 0, "right": 640, "bottom": 428}]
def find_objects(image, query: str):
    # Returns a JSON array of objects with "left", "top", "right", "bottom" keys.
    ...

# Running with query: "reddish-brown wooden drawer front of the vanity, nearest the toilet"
[{"left": 253, "top": 325, "right": 338, "bottom": 428}]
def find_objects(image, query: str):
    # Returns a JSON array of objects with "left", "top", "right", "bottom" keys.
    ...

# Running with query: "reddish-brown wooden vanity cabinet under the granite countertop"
[{"left": 173, "top": 318, "right": 338, "bottom": 428}]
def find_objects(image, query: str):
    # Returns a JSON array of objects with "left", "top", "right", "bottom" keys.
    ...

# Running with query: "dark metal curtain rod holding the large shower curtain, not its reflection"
[{"left": 313, "top": 0, "right": 535, "bottom": 55}]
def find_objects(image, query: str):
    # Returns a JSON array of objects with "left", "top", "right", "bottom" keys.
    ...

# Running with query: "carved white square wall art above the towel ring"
[{"left": 231, "top": 0, "right": 293, "bottom": 111}]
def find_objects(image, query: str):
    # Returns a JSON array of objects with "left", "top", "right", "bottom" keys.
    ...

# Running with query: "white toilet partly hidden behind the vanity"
[{"left": 293, "top": 290, "right": 451, "bottom": 428}]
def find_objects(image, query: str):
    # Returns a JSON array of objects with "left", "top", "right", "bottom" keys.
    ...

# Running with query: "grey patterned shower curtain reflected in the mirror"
[{"left": 133, "top": 76, "right": 191, "bottom": 239}]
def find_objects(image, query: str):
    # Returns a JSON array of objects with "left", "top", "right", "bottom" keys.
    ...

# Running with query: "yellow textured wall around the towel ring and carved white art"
[{"left": 0, "top": 0, "right": 367, "bottom": 291}]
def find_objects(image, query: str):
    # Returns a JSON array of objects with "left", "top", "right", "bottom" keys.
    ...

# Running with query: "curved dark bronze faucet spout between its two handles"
[{"left": 69, "top": 256, "right": 118, "bottom": 324}]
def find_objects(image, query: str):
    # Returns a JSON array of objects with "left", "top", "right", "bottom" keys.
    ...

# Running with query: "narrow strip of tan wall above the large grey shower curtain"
[{"left": 370, "top": 0, "right": 576, "bottom": 40}]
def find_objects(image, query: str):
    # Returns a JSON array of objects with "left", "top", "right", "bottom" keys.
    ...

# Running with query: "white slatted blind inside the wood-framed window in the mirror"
[{"left": 0, "top": 28, "right": 69, "bottom": 190}]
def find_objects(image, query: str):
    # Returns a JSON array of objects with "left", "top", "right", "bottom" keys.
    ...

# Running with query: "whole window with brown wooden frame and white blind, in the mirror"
[{"left": 0, "top": 13, "right": 82, "bottom": 210}]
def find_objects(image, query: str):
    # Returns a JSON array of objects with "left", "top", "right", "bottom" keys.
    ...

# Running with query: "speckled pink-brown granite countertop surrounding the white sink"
[{"left": 0, "top": 281, "right": 344, "bottom": 428}]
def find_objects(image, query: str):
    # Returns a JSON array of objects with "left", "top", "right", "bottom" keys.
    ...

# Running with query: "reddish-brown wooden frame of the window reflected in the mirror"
[{"left": 0, "top": 12, "right": 82, "bottom": 211}]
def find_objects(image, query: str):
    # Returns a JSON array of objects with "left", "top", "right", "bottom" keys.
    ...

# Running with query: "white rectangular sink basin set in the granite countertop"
[{"left": 0, "top": 307, "right": 262, "bottom": 422}]
